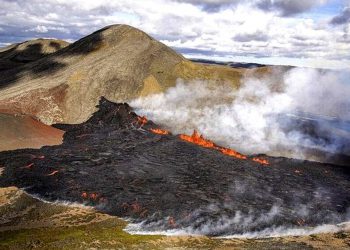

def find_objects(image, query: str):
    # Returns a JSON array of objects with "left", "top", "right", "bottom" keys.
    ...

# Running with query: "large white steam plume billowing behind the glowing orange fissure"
[{"left": 131, "top": 67, "right": 350, "bottom": 160}]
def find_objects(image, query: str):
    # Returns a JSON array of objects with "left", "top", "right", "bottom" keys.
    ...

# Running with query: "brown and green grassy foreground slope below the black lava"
[{"left": 0, "top": 187, "right": 350, "bottom": 250}]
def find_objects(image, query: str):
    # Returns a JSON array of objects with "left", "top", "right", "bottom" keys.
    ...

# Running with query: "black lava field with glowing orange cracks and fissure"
[{"left": 0, "top": 98, "right": 350, "bottom": 235}]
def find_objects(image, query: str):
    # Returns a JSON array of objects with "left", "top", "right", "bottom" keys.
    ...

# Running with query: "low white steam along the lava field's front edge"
[{"left": 126, "top": 181, "right": 350, "bottom": 238}]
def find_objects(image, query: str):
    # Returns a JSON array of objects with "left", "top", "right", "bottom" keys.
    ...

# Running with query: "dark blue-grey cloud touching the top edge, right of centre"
[{"left": 257, "top": 0, "right": 325, "bottom": 16}]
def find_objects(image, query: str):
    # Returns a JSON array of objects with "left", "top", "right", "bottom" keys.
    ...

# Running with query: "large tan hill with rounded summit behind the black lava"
[{"left": 0, "top": 25, "right": 266, "bottom": 124}]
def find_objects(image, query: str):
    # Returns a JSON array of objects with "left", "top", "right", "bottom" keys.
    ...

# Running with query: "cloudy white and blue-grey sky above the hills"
[{"left": 0, "top": 0, "right": 350, "bottom": 69}]
